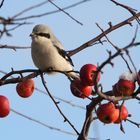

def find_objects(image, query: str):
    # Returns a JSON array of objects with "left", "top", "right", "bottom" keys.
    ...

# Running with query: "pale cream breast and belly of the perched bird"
[{"left": 31, "top": 37, "right": 73, "bottom": 71}]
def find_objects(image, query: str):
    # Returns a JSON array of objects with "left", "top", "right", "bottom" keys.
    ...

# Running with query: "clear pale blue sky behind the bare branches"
[{"left": 0, "top": 0, "right": 140, "bottom": 140}]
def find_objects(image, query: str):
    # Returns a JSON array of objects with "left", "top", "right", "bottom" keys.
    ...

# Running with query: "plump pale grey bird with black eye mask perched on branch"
[{"left": 30, "top": 24, "right": 79, "bottom": 79}]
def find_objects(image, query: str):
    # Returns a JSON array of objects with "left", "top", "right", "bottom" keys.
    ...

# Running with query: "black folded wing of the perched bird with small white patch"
[{"left": 54, "top": 45, "right": 74, "bottom": 66}]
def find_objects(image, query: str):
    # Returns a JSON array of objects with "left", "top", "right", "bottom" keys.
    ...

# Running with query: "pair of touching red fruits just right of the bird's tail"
[{"left": 70, "top": 64, "right": 100, "bottom": 98}]
